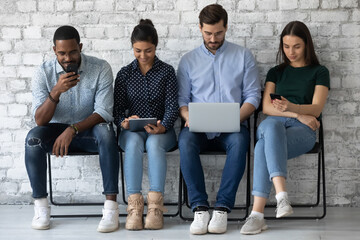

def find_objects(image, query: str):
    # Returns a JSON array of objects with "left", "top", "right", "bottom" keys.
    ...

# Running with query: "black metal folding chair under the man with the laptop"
[{"left": 178, "top": 120, "right": 251, "bottom": 221}]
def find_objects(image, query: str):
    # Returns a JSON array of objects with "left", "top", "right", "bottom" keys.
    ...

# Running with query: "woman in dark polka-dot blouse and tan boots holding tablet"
[{"left": 114, "top": 19, "right": 178, "bottom": 230}]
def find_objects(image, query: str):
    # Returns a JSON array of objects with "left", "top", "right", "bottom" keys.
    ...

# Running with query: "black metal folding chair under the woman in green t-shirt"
[{"left": 254, "top": 101, "right": 326, "bottom": 219}]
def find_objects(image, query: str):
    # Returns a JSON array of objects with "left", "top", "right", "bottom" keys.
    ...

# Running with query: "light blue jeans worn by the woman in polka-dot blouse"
[{"left": 119, "top": 128, "right": 176, "bottom": 195}]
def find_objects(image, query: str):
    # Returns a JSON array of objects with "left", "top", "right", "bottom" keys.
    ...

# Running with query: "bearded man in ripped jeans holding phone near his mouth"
[{"left": 25, "top": 26, "right": 119, "bottom": 232}]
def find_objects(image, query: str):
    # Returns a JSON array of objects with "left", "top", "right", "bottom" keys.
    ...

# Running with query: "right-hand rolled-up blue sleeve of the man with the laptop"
[{"left": 242, "top": 50, "right": 261, "bottom": 108}]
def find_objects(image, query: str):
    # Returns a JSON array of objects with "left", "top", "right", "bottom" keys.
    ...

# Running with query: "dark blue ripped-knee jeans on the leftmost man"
[{"left": 25, "top": 123, "right": 119, "bottom": 198}]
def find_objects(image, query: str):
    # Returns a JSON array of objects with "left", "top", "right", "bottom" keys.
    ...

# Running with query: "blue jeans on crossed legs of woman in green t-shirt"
[{"left": 252, "top": 116, "right": 316, "bottom": 198}]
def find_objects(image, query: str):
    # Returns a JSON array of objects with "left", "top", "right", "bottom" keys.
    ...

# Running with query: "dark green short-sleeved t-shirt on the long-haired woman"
[{"left": 266, "top": 65, "right": 330, "bottom": 104}]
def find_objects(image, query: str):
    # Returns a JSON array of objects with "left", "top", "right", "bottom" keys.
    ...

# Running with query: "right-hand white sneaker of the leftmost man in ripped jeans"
[{"left": 97, "top": 200, "right": 119, "bottom": 232}]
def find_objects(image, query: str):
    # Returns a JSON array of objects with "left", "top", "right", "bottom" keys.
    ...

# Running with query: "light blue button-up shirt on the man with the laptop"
[{"left": 177, "top": 41, "right": 261, "bottom": 139}]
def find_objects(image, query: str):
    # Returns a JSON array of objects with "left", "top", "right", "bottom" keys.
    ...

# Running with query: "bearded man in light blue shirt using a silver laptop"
[{"left": 178, "top": 4, "right": 260, "bottom": 234}]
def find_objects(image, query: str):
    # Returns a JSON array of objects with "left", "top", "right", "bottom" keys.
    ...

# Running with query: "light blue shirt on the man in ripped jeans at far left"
[{"left": 32, "top": 54, "right": 114, "bottom": 124}]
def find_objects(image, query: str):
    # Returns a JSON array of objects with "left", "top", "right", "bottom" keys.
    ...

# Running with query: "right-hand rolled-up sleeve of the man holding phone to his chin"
[{"left": 94, "top": 62, "right": 114, "bottom": 122}]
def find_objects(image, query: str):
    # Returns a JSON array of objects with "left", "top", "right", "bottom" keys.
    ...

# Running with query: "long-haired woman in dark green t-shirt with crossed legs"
[{"left": 240, "top": 21, "right": 330, "bottom": 234}]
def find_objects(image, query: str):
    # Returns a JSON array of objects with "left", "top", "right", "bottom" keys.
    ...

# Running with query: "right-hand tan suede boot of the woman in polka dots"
[{"left": 145, "top": 192, "right": 167, "bottom": 230}]
